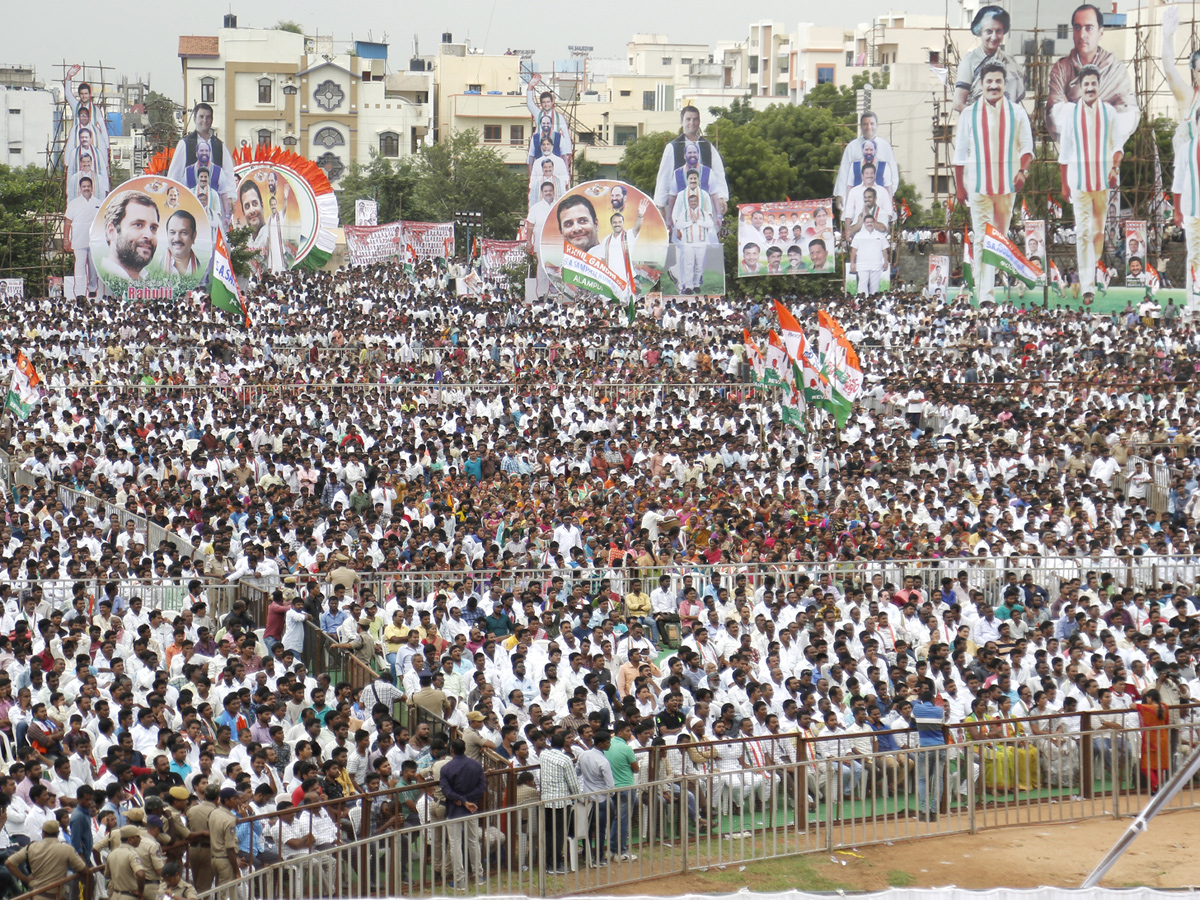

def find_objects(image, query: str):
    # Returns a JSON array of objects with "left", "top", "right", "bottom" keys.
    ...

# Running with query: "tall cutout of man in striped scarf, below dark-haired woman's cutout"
[{"left": 954, "top": 62, "right": 1033, "bottom": 304}]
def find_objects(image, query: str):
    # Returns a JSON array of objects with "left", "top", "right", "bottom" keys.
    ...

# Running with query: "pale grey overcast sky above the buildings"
[{"left": 0, "top": 0, "right": 958, "bottom": 101}]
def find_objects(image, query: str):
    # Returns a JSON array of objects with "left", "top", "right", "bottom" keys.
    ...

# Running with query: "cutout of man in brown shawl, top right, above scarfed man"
[{"left": 1046, "top": 4, "right": 1141, "bottom": 140}]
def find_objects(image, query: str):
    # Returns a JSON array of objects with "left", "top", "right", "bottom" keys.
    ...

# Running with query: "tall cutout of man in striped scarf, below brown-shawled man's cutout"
[{"left": 1055, "top": 65, "right": 1138, "bottom": 302}]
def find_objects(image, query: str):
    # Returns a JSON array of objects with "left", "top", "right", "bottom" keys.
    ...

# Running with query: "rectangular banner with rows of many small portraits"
[{"left": 738, "top": 199, "right": 836, "bottom": 278}]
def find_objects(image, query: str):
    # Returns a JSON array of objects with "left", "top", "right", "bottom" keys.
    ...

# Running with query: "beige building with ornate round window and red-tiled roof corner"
[{"left": 179, "top": 16, "right": 433, "bottom": 184}]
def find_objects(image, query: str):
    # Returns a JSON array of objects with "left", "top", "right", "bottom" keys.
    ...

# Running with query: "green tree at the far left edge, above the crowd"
[{"left": 0, "top": 166, "right": 70, "bottom": 296}]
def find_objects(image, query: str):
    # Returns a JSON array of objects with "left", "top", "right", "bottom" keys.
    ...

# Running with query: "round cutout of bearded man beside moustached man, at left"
[{"left": 91, "top": 175, "right": 212, "bottom": 300}]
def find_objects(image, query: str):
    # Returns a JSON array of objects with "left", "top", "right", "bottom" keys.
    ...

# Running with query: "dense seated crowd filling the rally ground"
[{"left": 0, "top": 256, "right": 1200, "bottom": 900}]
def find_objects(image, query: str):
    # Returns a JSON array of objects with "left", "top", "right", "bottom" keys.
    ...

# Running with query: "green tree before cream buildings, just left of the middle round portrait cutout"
[{"left": 414, "top": 130, "right": 528, "bottom": 239}]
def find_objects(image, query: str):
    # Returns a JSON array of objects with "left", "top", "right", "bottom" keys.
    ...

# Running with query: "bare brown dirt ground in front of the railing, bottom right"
[{"left": 604, "top": 810, "right": 1200, "bottom": 896}]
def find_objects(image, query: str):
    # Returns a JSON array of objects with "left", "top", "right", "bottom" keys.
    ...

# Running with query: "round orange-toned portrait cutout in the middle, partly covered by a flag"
[{"left": 539, "top": 180, "right": 667, "bottom": 296}]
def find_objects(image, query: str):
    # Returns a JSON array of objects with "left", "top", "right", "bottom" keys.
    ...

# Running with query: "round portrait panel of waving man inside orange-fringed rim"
[{"left": 233, "top": 164, "right": 317, "bottom": 272}]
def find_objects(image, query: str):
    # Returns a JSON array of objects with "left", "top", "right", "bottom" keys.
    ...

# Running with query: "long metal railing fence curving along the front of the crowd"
[{"left": 192, "top": 710, "right": 1200, "bottom": 898}]
